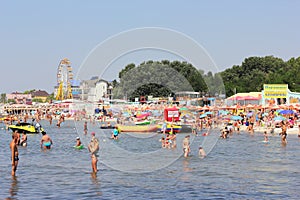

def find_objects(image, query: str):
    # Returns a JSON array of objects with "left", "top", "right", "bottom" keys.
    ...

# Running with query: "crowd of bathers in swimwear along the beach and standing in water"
[{"left": 5, "top": 104, "right": 300, "bottom": 175}]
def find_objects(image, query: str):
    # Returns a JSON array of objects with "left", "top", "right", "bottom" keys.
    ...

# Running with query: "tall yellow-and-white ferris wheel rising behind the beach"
[{"left": 56, "top": 58, "right": 73, "bottom": 100}]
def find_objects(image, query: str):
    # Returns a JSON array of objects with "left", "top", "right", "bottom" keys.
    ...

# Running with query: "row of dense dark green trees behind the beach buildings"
[{"left": 113, "top": 56, "right": 300, "bottom": 100}]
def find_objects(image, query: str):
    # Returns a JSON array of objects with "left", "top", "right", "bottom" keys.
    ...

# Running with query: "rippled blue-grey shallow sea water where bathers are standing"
[{"left": 0, "top": 121, "right": 300, "bottom": 199}]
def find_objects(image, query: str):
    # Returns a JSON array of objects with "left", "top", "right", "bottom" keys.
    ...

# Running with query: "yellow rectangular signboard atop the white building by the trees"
[{"left": 264, "top": 84, "right": 288, "bottom": 99}]
